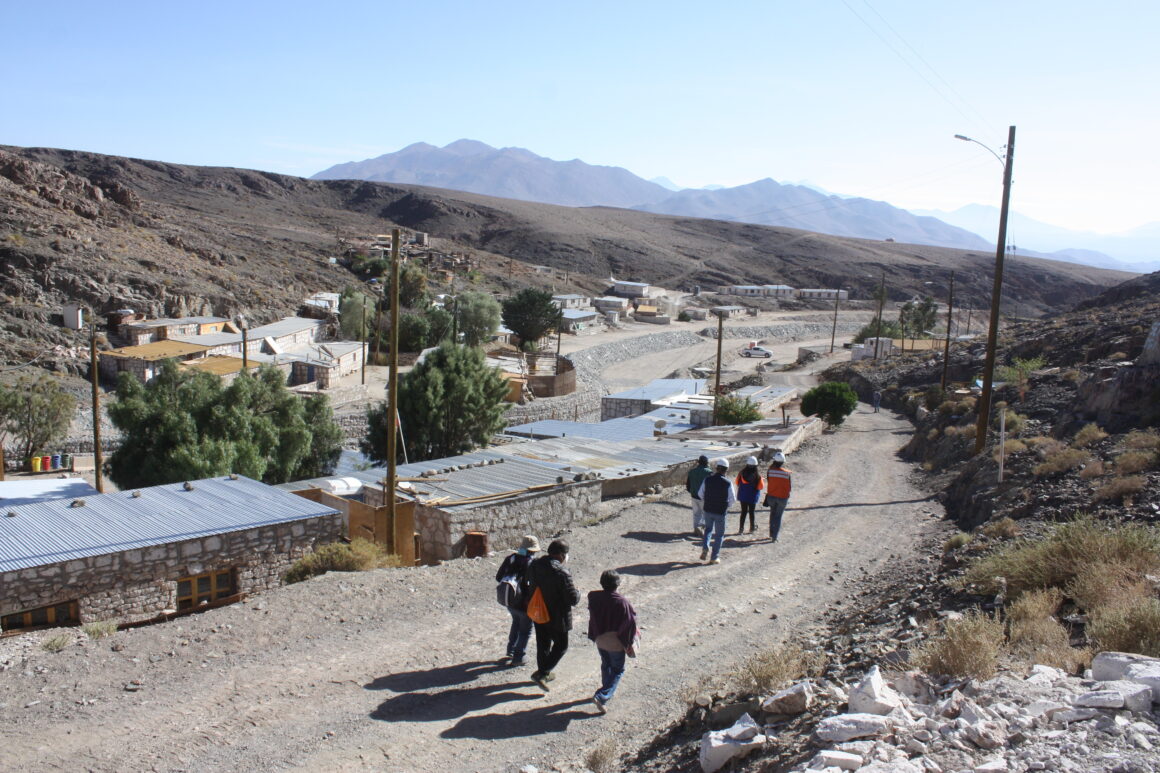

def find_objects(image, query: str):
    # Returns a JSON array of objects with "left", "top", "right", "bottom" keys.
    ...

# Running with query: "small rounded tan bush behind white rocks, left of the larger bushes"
[{"left": 911, "top": 611, "right": 1005, "bottom": 679}]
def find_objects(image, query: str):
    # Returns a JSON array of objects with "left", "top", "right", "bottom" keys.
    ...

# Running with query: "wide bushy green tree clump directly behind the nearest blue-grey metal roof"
[{"left": 109, "top": 362, "right": 342, "bottom": 489}]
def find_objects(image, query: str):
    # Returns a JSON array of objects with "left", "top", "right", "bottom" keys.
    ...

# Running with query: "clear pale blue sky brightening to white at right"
[{"left": 0, "top": 0, "right": 1160, "bottom": 233}]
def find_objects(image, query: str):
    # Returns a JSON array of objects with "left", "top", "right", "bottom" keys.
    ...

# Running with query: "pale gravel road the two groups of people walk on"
[{"left": 0, "top": 406, "right": 940, "bottom": 772}]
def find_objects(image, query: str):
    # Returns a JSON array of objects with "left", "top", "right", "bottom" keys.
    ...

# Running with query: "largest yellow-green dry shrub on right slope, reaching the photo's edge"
[{"left": 958, "top": 515, "right": 1160, "bottom": 599}]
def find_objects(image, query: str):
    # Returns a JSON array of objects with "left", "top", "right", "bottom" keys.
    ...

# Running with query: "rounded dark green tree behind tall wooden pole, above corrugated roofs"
[{"left": 361, "top": 344, "right": 508, "bottom": 462}]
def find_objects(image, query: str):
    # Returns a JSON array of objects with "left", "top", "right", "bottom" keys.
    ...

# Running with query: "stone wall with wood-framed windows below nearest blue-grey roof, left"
[{"left": 0, "top": 513, "right": 342, "bottom": 622}]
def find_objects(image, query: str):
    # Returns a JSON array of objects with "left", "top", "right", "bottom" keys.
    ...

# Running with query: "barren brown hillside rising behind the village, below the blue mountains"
[{"left": 0, "top": 147, "right": 1130, "bottom": 367}]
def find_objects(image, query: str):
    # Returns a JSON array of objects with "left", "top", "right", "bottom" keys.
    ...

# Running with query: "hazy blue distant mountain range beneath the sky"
[{"left": 312, "top": 139, "right": 1160, "bottom": 272}]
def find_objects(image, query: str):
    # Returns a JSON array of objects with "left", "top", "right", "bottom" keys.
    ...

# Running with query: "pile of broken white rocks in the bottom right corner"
[{"left": 702, "top": 652, "right": 1160, "bottom": 773}]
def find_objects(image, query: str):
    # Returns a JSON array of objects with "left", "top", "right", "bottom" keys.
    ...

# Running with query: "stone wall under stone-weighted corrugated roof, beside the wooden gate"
[{"left": 415, "top": 481, "right": 602, "bottom": 563}]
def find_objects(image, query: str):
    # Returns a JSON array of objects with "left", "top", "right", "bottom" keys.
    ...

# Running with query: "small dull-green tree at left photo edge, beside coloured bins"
[{"left": 0, "top": 374, "right": 77, "bottom": 458}]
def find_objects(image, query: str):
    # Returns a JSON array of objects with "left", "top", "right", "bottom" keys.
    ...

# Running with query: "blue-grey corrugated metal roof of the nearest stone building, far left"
[{"left": 0, "top": 476, "right": 338, "bottom": 572}]
